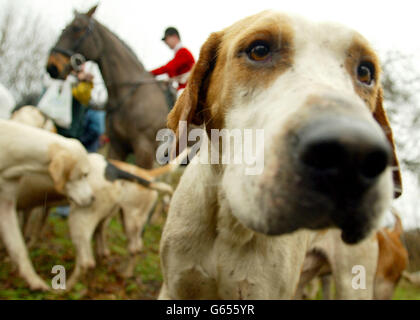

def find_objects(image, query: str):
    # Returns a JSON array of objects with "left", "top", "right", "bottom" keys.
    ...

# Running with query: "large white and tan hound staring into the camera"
[{"left": 160, "top": 11, "right": 401, "bottom": 299}]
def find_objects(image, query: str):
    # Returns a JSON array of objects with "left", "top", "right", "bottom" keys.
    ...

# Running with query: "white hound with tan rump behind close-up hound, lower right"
[{"left": 296, "top": 208, "right": 408, "bottom": 300}]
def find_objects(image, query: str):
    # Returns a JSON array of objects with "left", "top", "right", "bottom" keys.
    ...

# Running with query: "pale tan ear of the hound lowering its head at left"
[{"left": 48, "top": 146, "right": 75, "bottom": 193}]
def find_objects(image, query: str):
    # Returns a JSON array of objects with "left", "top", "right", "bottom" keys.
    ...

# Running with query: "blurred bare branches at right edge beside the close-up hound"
[{"left": 382, "top": 51, "right": 420, "bottom": 231}]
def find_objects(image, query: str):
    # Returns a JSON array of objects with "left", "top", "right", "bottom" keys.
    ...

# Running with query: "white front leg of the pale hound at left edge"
[{"left": 0, "top": 198, "right": 50, "bottom": 291}]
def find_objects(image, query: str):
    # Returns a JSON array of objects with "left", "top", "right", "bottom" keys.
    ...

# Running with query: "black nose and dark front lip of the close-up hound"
[{"left": 296, "top": 116, "right": 392, "bottom": 243}]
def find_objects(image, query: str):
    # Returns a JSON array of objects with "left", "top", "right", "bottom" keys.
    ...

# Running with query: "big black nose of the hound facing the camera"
[{"left": 298, "top": 117, "right": 392, "bottom": 193}]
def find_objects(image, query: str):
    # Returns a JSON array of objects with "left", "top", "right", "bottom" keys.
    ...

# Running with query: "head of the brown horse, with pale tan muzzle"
[{"left": 47, "top": 5, "right": 102, "bottom": 79}]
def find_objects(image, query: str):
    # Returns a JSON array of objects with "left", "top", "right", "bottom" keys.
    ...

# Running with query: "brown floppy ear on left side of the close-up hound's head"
[{"left": 167, "top": 32, "right": 222, "bottom": 158}]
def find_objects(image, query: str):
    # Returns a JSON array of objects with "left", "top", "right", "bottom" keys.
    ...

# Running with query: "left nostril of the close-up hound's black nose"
[{"left": 301, "top": 141, "right": 347, "bottom": 171}]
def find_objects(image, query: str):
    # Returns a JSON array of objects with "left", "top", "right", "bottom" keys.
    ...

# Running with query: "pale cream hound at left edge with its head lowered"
[{"left": 0, "top": 120, "right": 94, "bottom": 290}]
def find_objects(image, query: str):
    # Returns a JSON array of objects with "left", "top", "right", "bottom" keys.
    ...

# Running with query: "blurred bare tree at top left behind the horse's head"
[{"left": 0, "top": 0, "right": 54, "bottom": 101}]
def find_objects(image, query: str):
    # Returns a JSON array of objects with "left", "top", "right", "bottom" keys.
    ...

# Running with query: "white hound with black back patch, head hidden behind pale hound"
[{"left": 66, "top": 153, "right": 177, "bottom": 290}]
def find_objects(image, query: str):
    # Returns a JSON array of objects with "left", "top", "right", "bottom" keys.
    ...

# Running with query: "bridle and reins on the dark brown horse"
[{"left": 51, "top": 18, "right": 169, "bottom": 113}]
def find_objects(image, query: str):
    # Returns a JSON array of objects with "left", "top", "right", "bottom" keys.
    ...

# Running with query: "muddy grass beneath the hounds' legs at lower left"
[{"left": 0, "top": 210, "right": 163, "bottom": 300}]
